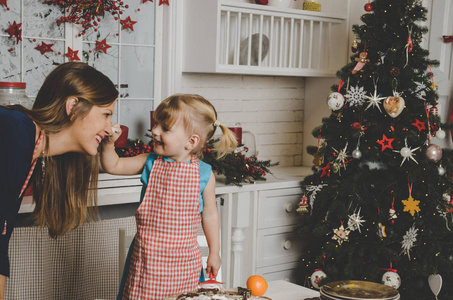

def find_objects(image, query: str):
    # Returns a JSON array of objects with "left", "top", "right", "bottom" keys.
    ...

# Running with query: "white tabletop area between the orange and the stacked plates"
[{"left": 264, "top": 280, "right": 319, "bottom": 300}]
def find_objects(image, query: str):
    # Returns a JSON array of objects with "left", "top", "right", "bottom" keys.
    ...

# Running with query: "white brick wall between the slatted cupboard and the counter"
[{"left": 181, "top": 73, "right": 305, "bottom": 166}]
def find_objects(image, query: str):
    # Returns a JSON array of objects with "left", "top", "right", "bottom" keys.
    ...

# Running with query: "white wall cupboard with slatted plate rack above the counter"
[{"left": 182, "top": 0, "right": 349, "bottom": 76}]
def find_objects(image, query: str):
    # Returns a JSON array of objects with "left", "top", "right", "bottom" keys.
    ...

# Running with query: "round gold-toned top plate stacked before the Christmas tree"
[{"left": 321, "top": 280, "right": 399, "bottom": 300}]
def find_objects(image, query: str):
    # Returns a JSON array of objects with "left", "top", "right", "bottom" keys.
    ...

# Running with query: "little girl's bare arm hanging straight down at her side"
[{"left": 202, "top": 172, "right": 221, "bottom": 277}]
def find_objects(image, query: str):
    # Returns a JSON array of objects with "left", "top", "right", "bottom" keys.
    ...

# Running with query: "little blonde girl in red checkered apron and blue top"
[{"left": 101, "top": 94, "right": 236, "bottom": 300}]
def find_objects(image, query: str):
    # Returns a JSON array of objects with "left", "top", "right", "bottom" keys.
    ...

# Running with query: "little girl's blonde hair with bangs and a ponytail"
[{"left": 154, "top": 94, "right": 237, "bottom": 158}]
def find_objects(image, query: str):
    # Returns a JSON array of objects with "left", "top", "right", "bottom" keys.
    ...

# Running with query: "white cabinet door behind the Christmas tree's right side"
[{"left": 423, "top": 0, "right": 453, "bottom": 148}]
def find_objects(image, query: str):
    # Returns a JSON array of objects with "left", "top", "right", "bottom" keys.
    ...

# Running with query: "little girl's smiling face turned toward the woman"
[{"left": 152, "top": 120, "right": 190, "bottom": 161}]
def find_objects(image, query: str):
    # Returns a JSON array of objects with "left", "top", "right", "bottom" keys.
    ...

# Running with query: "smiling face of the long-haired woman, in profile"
[{"left": 72, "top": 102, "right": 115, "bottom": 155}]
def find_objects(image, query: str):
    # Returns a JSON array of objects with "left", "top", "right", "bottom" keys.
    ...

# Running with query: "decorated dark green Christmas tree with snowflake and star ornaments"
[{"left": 298, "top": 0, "right": 453, "bottom": 300}]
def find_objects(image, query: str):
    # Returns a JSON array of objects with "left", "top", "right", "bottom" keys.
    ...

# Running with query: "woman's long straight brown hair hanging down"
[{"left": 12, "top": 62, "right": 118, "bottom": 237}]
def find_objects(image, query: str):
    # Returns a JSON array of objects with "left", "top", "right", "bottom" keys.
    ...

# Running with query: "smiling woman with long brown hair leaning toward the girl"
[{"left": 0, "top": 62, "right": 118, "bottom": 300}]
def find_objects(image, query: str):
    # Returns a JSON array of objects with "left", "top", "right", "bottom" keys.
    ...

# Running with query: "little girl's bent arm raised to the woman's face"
[{"left": 101, "top": 124, "right": 149, "bottom": 175}]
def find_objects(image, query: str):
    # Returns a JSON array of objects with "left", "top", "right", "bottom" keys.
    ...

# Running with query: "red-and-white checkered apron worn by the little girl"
[{"left": 123, "top": 156, "right": 202, "bottom": 300}]
